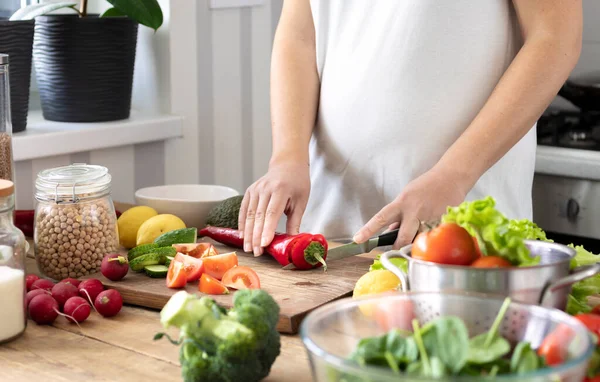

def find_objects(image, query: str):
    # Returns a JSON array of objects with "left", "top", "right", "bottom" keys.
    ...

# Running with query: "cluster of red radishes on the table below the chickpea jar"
[{"left": 26, "top": 275, "right": 123, "bottom": 325}]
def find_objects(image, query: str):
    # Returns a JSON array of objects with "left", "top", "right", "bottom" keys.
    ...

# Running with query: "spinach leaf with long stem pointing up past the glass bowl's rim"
[{"left": 468, "top": 297, "right": 510, "bottom": 364}]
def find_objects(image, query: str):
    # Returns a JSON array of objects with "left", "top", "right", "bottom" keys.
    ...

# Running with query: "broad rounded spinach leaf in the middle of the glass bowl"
[{"left": 422, "top": 316, "right": 469, "bottom": 374}]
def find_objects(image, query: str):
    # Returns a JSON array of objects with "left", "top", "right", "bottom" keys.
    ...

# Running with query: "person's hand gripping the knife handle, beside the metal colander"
[{"left": 354, "top": 169, "right": 470, "bottom": 249}]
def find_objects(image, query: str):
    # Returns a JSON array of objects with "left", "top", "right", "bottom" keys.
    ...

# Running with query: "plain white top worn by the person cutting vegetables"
[{"left": 301, "top": 0, "right": 536, "bottom": 238}]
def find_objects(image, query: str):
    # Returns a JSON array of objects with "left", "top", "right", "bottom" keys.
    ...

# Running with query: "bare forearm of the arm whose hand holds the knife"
[{"left": 436, "top": 0, "right": 581, "bottom": 189}]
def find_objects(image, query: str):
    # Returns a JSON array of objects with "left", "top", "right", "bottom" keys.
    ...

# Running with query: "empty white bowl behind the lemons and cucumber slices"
[{"left": 135, "top": 184, "right": 239, "bottom": 229}]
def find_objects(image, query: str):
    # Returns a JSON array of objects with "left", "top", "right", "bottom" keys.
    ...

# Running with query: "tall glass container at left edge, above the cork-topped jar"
[{"left": 0, "top": 54, "right": 15, "bottom": 181}]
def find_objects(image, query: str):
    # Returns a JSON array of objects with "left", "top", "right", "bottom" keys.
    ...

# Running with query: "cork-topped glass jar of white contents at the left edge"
[{"left": 0, "top": 179, "right": 27, "bottom": 343}]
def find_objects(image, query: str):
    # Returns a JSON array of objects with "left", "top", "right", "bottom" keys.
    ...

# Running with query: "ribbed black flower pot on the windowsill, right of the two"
[{"left": 33, "top": 15, "right": 138, "bottom": 122}]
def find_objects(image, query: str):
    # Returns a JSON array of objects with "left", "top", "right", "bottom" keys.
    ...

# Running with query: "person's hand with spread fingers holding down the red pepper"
[{"left": 238, "top": 162, "right": 310, "bottom": 256}]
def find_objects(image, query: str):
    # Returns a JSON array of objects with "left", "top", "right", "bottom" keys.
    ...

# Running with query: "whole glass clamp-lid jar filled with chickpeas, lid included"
[{"left": 34, "top": 164, "right": 119, "bottom": 281}]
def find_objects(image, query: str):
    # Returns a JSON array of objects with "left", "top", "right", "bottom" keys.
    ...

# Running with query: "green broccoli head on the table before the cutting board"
[{"left": 155, "top": 289, "right": 281, "bottom": 382}]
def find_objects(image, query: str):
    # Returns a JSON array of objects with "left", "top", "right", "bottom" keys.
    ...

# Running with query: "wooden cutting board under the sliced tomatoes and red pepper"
[{"left": 75, "top": 239, "right": 374, "bottom": 334}]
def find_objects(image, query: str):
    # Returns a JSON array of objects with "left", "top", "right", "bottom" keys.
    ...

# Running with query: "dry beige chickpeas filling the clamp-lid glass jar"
[{"left": 36, "top": 200, "right": 118, "bottom": 280}]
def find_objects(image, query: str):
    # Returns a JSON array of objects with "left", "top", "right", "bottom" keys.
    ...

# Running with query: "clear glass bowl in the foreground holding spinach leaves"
[{"left": 300, "top": 292, "right": 595, "bottom": 382}]
